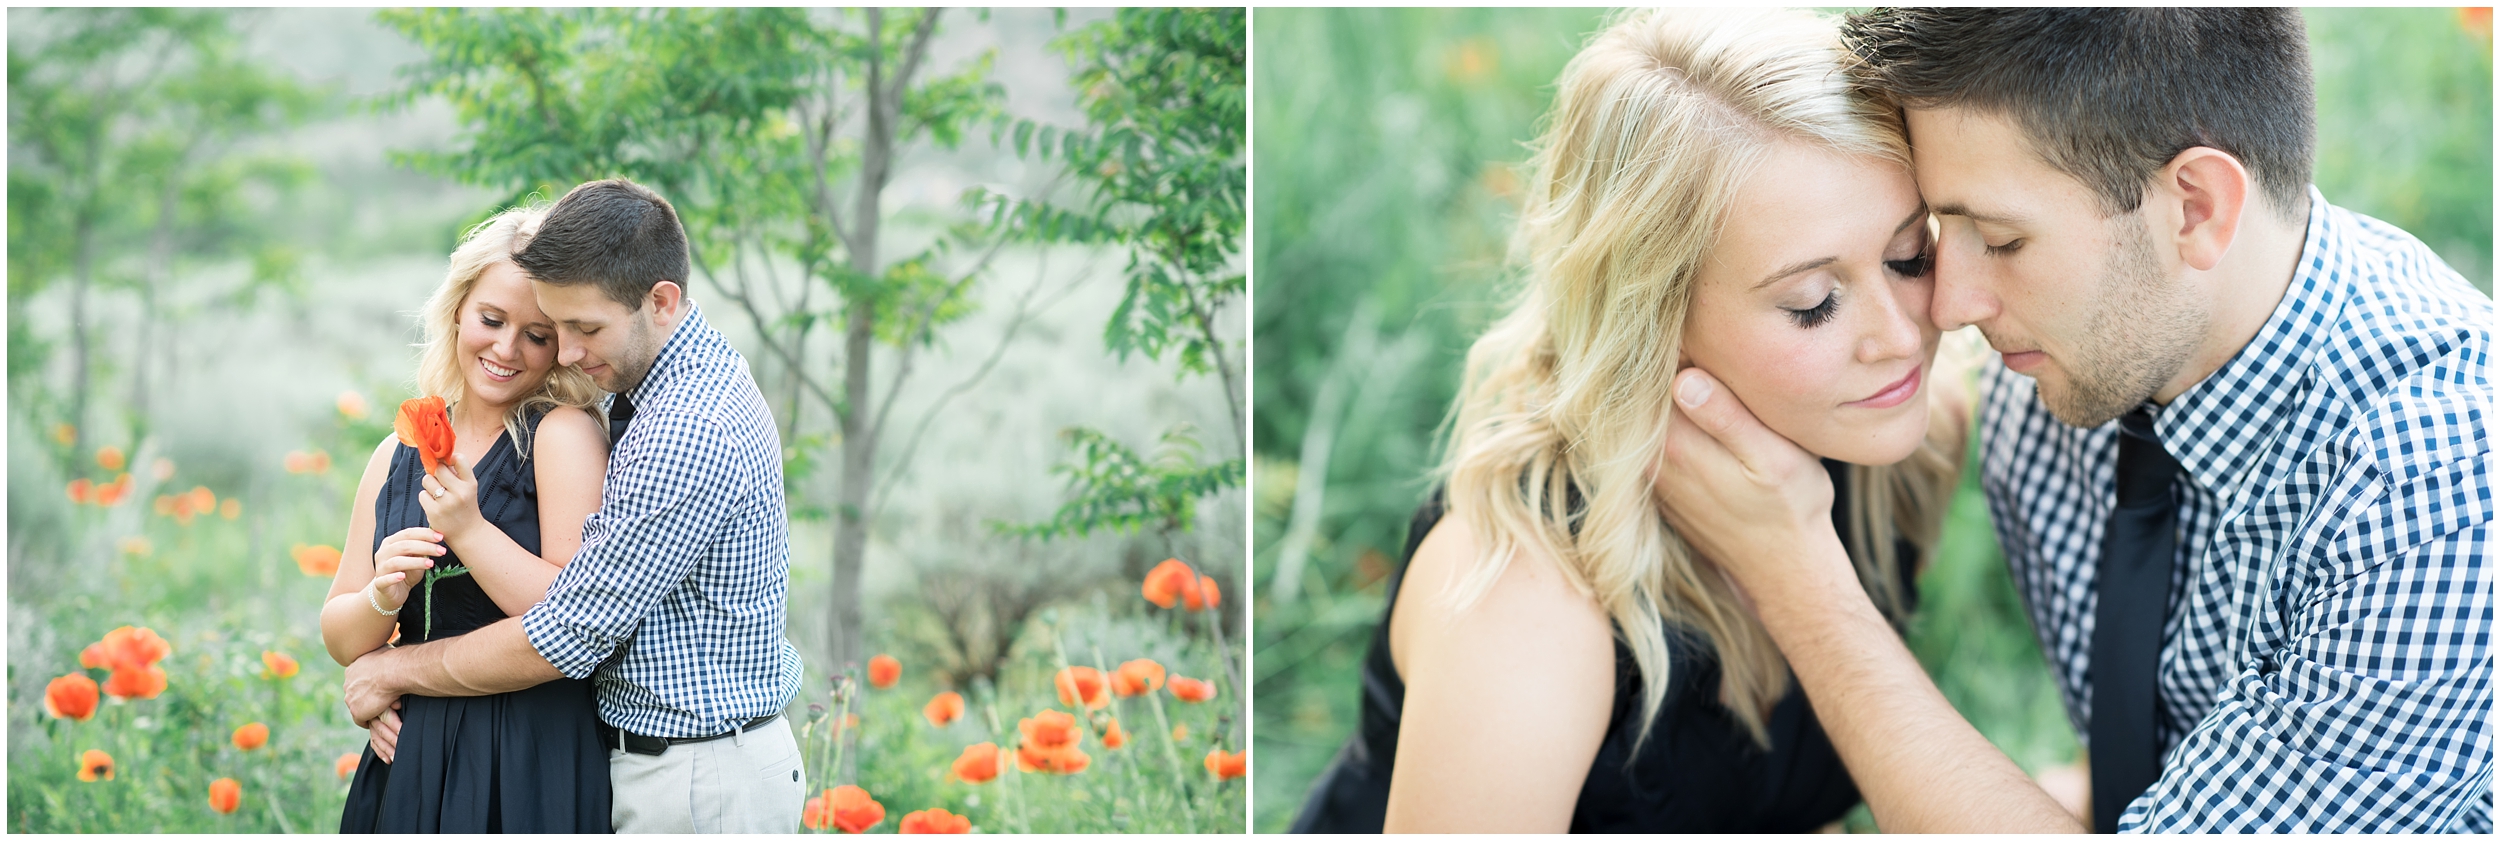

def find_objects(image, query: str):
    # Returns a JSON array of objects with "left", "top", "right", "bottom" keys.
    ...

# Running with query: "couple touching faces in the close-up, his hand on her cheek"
[{"left": 1295, "top": 10, "right": 2493, "bottom": 833}]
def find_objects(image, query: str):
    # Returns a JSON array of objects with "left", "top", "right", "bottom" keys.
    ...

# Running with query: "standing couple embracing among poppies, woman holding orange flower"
[{"left": 323, "top": 180, "right": 808, "bottom": 833}]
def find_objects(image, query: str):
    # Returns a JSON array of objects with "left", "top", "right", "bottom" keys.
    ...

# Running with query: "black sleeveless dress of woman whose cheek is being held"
[{"left": 1293, "top": 461, "right": 1918, "bottom": 833}]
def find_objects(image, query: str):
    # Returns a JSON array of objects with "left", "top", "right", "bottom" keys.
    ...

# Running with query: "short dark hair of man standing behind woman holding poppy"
[{"left": 513, "top": 178, "right": 690, "bottom": 310}]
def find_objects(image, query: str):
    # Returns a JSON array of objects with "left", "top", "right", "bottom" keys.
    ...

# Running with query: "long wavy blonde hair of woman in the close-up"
[{"left": 1440, "top": 10, "right": 1960, "bottom": 748}]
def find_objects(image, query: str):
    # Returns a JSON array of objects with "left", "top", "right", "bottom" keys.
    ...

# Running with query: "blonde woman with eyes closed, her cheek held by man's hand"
[{"left": 1295, "top": 10, "right": 1968, "bottom": 831}]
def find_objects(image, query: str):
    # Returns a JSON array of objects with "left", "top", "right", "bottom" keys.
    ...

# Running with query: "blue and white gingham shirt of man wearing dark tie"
[{"left": 1980, "top": 188, "right": 2493, "bottom": 833}]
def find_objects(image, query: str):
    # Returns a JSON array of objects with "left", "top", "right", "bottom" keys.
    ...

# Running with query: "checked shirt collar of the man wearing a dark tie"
[{"left": 2153, "top": 185, "right": 2353, "bottom": 508}]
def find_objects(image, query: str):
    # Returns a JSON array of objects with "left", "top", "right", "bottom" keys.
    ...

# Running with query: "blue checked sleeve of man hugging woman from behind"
[{"left": 523, "top": 413, "right": 738, "bottom": 678}]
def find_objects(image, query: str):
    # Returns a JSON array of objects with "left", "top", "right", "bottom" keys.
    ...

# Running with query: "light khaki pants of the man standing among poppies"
[{"left": 608, "top": 716, "right": 808, "bottom": 833}]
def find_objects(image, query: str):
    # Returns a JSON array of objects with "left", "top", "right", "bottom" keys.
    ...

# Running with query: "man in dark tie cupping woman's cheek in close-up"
[{"left": 1660, "top": 8, "right": 2493, "bottom": 833}]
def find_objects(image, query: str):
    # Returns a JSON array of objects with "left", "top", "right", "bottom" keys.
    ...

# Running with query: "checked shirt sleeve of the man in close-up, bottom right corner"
[{"left": 2118, "top": 456, "right": 2493, "bottom": 833}]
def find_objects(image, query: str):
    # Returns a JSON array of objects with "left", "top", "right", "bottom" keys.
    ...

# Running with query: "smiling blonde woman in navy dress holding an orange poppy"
[{"left": 323, "top": 208, "right": 610, "bottom": 833}]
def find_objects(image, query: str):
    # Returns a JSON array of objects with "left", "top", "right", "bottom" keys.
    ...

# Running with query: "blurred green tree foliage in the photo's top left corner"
[{"left": 8, "top": 8, "right": 328, "bottom": 456}]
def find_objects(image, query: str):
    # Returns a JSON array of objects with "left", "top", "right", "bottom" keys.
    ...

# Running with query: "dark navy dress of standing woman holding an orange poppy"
[{"left": 338, "top": 415, "right": 610, "bottom": 833}]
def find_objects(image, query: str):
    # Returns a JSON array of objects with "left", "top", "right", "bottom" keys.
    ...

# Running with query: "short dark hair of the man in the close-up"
[{"left": 1840, "top": 8, "right": 2318, "bottom": 218}]
